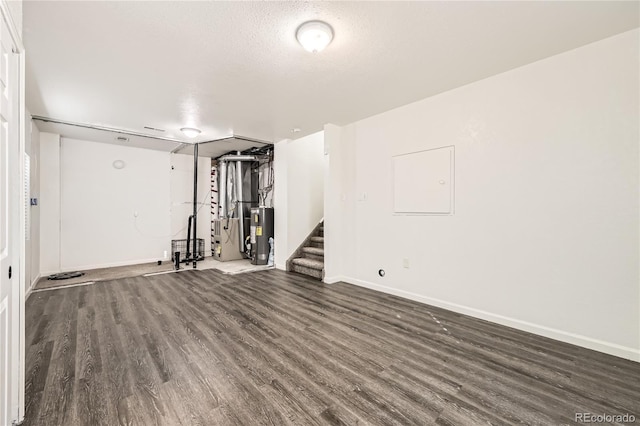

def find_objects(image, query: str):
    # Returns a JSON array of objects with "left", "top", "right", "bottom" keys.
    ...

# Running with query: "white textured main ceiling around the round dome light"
[{"left": 24, "top": 1, "right": 640, "bottom": 149}]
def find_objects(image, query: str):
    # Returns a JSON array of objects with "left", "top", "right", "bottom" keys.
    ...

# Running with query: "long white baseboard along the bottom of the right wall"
[{"left": 340, "top": 277, "right": 640, "bottom": 362}]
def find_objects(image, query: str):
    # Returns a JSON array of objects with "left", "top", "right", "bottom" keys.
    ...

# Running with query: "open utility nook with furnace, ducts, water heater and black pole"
[{"left": 171, "top": 137, "right": 275, "bottom": 269}]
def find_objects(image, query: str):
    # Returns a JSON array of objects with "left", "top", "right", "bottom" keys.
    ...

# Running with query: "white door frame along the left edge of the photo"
[{"left": 0, "top": 0, "right": 27, "bottom": 424}]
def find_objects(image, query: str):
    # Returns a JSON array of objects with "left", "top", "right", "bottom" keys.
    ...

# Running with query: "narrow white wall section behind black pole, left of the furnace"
[{"left": 169, "top": 154, "right": 211, "bottom": 256}]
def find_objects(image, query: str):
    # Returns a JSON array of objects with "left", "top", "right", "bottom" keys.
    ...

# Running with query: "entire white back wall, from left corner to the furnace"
[{"left": 40, "top": 133, "right": 211, "bottom": 275}]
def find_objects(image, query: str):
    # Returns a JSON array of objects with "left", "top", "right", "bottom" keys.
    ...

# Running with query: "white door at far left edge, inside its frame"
[{"left": 0, "top": 8, "right": 21, "bottom": 425}]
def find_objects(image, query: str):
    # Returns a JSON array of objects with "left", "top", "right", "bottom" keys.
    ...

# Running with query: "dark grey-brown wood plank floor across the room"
[{"left": 24, "top": 270, "right": 640, "bottom": 426}]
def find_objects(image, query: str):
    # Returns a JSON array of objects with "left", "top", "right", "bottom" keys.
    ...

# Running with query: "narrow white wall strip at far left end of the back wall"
[{"left": 38, "top": 132, "right": 60, "bottom": 275}]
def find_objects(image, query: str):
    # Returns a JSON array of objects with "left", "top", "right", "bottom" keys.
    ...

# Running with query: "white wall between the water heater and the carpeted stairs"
[{"left": 274, "top": 132, "right": 325, "bottom": 269}]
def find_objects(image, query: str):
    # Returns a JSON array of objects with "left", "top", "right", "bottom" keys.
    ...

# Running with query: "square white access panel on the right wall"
[{"left": 393, "top": 146, "right": 455, "bottom": 215}]
